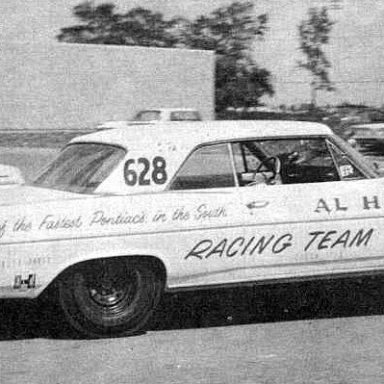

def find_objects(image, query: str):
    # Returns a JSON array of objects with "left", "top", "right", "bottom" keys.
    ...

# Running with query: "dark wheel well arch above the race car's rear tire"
[{"left": 40, "top": 255, "right": 167, "bottom": 301}]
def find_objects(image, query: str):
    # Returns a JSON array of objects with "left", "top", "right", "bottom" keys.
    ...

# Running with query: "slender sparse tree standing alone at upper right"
[{"left": 298, "top": 7, "right": 335, "bottom": 107}]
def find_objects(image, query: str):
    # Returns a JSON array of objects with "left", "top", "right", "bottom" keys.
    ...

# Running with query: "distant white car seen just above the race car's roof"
[{"left": 98, "top": 108, "right": 202, "bottom": 129}]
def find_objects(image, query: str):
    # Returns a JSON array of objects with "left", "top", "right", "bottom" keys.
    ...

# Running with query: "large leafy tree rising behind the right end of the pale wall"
[{"left": 177, "top": 2, "right": 273, "bottom": 112}]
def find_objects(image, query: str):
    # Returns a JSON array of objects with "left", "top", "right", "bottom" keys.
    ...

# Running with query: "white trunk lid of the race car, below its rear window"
[{"left": 0, "top": 185, "right": 94, "bottom": 206}]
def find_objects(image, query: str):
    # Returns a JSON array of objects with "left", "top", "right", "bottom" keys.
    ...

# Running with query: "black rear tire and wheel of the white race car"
[{"left": 58, "top": 258, "right": 164, "bottom": 337}]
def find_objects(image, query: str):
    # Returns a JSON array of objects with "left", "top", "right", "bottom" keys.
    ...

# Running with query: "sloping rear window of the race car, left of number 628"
[{"left": 33, "top": 143, "right": 125, "bottom": 193}]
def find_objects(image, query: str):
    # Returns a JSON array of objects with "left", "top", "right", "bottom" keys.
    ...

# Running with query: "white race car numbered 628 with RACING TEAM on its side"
[{"left": 0, "top": 121, "right": 384, "bottom": 337}]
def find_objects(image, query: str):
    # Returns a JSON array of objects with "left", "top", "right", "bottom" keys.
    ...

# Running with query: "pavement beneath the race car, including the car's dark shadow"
[{"left": 0, "top": 278, "right": 384, "bottom": 384}]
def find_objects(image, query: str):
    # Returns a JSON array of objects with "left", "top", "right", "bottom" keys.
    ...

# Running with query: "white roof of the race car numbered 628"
[{"left": 71, "top": 120, "right": 332, "bottom": 150}]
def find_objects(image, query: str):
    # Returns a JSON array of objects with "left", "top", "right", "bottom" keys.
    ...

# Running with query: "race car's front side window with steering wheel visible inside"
[{"left": 232, "top": 138, "right": 340, "bottom": 186}]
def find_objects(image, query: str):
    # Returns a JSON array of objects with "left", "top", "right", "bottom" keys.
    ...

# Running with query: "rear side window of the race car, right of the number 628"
[{"left": 170, "top": 144, "right": 235, "bottom": 190}]
